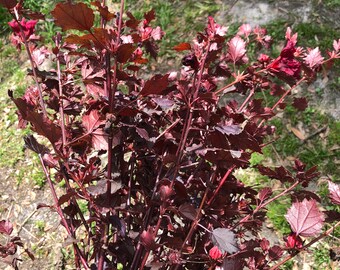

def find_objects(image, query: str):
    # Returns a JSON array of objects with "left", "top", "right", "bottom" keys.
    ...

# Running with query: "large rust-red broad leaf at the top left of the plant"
[{"left": 51, "top": 3, "right": 94, "bottom": 31}]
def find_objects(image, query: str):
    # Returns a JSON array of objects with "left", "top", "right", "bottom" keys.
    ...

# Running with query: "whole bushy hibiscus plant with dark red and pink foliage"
[{"left": 0, "top": 0, "right": 340, "bottom": 270}]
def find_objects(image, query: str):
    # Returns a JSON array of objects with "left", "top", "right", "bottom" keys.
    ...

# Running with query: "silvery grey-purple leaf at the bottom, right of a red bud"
[{"left": 211, "top": 228, "right": 239, "bottom": 254}]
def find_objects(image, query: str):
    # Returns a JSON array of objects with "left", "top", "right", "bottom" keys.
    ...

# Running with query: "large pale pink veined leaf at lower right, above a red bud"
[{"left": 285, "top": 199, "right": 325, "bottom": 237}]
